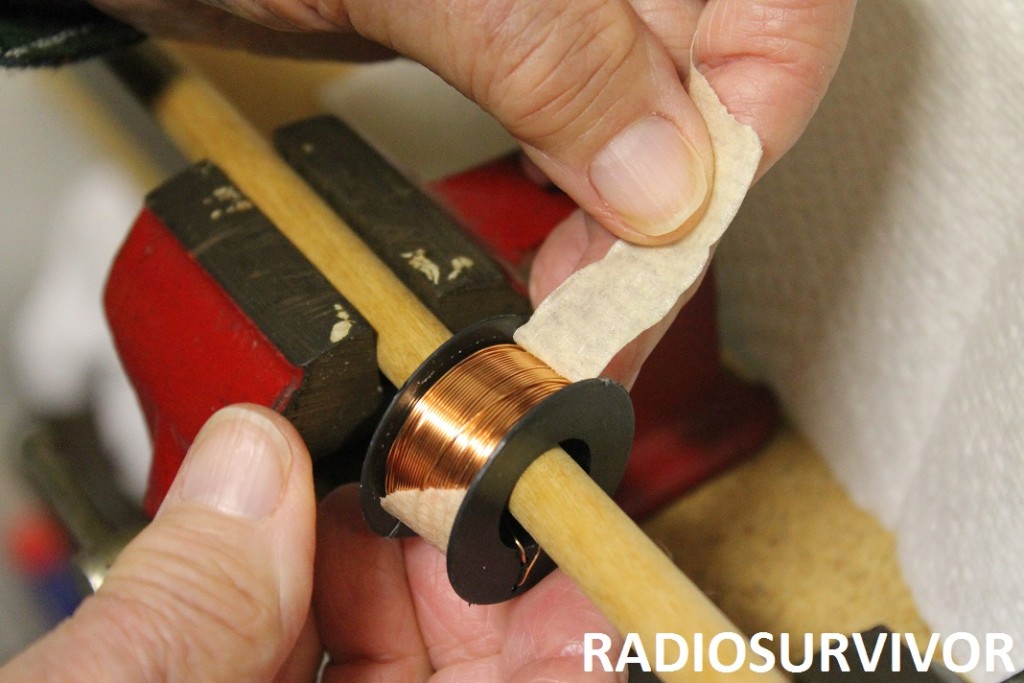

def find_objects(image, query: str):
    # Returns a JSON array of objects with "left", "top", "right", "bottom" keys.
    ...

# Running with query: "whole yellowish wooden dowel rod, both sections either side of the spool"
[{"left": 115, "top": 47, "right": 781, "bottom": 681}]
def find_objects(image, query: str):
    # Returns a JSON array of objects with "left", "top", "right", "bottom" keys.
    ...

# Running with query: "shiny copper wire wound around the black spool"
[{"left": 384, "top": 344, "right": 568, "bottom": 494}]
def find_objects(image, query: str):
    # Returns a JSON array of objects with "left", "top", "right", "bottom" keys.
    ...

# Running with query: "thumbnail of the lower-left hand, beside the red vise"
[{"left": 180, "top": 407, "right": 292, "bottom": 520}]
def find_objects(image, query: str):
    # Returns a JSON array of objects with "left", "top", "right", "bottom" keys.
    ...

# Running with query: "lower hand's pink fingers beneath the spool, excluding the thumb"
[{"left": 313, "top": 486, "right": 621, "bottom": 683}]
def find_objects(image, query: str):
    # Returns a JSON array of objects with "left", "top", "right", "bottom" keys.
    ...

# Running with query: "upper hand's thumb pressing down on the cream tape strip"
[{"left": 311, "top": 0, "right": 712, "bottom": 244}]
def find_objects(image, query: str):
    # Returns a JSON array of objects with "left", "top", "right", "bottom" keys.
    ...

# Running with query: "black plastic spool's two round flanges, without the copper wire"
[{"left": 360, "top": 316, "right": 633, "bottom": 604}]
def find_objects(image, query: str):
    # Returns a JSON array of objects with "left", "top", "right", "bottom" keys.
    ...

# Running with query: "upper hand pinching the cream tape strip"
[{"left": 91, "top": 0, "right": 855, "bottom": 384}]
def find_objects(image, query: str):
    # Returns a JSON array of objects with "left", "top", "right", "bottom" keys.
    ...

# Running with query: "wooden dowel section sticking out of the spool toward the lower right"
[{"left": 509, "top": 449, "right": 785, "bottom": 682}]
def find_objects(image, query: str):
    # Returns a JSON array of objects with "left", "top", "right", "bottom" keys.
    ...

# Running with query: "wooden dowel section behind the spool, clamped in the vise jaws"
[{"left": 113, "top": 45, "right": 452, "bottom": 386}]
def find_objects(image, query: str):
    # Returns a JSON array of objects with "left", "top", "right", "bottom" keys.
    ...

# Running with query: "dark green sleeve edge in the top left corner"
[{"left": 0, "top": 0, "right": 144, "bottom": 67}]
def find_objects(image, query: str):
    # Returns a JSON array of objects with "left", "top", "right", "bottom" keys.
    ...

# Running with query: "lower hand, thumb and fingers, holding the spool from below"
[{"left": 0, "top": 408, "right": 611, "bottom": 682}]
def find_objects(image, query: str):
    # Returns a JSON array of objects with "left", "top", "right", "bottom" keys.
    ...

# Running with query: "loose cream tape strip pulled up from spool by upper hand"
[{"left": 515, "top": 70, "right": 761, "bottom": 382}]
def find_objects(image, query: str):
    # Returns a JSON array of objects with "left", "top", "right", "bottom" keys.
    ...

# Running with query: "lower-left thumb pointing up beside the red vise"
[{"left": 0, "top": 407, "right": 315, "bottom": 681}]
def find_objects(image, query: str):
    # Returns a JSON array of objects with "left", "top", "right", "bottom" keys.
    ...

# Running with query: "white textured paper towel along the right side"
[{"left": 718, "top": 0, "right": 1024, "bottom": 680}]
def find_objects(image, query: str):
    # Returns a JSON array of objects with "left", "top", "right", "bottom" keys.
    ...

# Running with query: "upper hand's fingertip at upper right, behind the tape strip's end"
[{"left": 693, "top": 0, "right": 856, "bottom": 179}]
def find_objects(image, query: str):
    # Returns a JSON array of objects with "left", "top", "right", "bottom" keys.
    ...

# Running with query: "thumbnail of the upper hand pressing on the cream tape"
[{"left": 590, "top": 116, "right": 708, "bottom": 237}]
